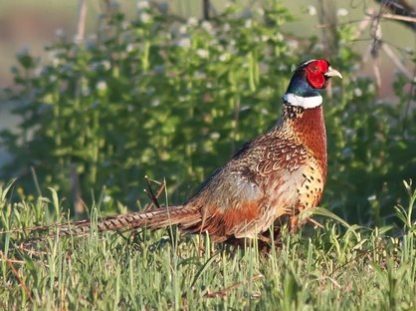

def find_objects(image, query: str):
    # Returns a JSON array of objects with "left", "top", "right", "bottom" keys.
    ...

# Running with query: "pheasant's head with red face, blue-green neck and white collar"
[{"left": 283, "top": 59, "right": 342, "bottom": 109}]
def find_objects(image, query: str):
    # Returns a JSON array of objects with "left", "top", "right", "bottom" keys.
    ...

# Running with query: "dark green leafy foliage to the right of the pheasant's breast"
[{"left": 327, "top": 76, "right": 416, "bottom": 225}]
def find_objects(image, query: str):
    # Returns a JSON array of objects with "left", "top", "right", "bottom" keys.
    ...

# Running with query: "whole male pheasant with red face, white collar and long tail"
[{"left": 19, "top": 59, "right": 342, "bottom": 242}]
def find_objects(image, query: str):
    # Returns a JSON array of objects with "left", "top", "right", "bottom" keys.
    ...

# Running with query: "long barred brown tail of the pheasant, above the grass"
[{"left": 45, "top": 206, "right": 201, "bottom": 236}]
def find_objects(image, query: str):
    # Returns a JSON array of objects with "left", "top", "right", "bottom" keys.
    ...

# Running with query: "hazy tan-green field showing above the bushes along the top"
[{"left": 0, "top": 0, "right": 416, "bottom": 90}]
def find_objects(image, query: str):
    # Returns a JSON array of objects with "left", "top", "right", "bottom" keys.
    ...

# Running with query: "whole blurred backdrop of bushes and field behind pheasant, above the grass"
[{"left": 0, "top": 0, "right": 416, "bottom": 227}]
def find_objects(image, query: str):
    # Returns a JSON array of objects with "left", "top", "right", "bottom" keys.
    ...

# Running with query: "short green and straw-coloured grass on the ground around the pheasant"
[{"left": 0, "top": 184, "right": 416, "bottom": 310}]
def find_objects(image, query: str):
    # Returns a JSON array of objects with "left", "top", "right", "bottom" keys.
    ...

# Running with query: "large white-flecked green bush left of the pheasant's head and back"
[{"left": 3, "top": 4, "right": 297, "bottom": 207}]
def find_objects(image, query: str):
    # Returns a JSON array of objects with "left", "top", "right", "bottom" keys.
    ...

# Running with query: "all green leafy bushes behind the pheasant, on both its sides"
[{"left": 1, "top": 1, "right": 416, "bottom": 224}]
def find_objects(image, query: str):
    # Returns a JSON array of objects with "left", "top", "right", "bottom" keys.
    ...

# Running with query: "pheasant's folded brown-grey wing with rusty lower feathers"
[{"left": 182, "top": 132, "right": 307, "bottom": 240}]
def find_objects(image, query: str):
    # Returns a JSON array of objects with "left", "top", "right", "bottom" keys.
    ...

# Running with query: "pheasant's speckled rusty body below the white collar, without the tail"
[{"left": 181, "top": 106, "right": 327, "bottom": 241}]
